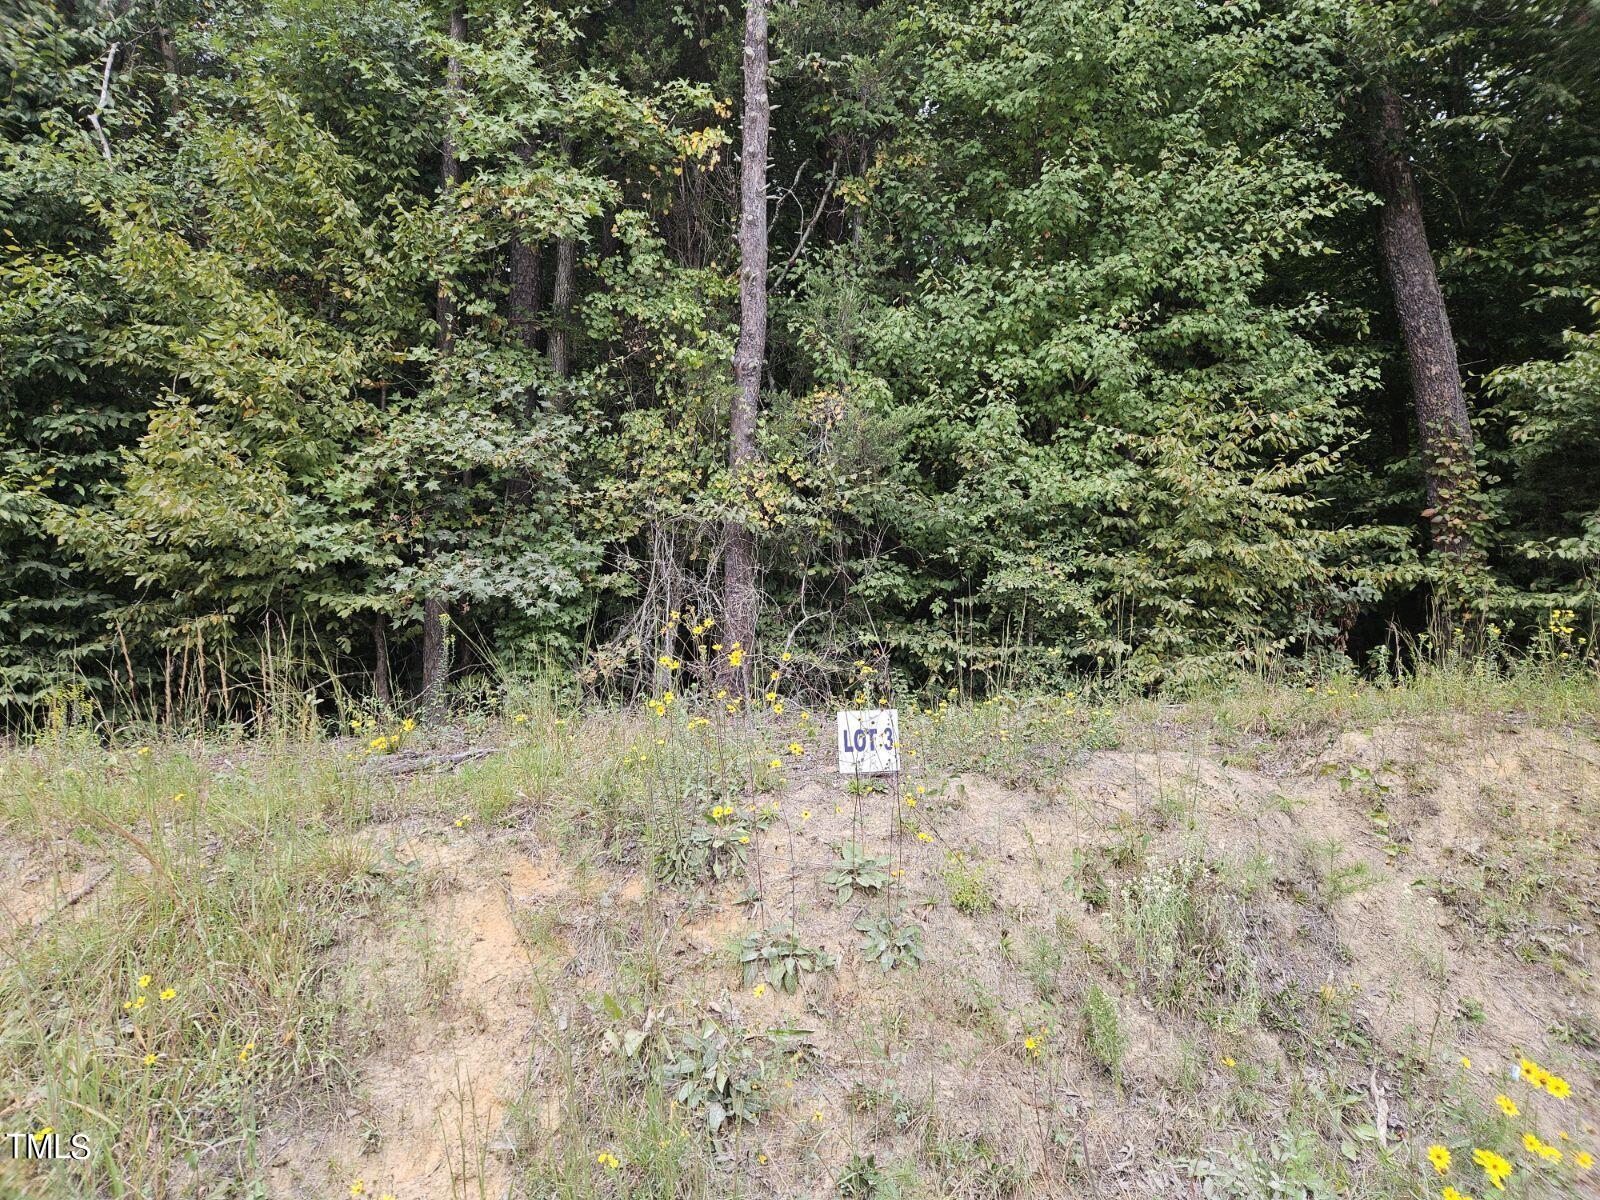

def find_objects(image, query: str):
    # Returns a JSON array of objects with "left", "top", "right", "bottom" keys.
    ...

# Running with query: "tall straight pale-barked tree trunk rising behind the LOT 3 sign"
[{"left": 720, "top": 0, "right": 771, "bottom": 690}]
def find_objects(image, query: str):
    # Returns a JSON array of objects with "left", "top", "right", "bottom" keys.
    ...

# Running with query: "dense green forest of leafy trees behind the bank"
[{"left": 0, "top": 0, "right": 1600, "bottom": 720}]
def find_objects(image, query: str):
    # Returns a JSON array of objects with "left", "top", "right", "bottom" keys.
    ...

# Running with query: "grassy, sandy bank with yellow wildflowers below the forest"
[{"left": 0, "top": 674, "right": 1600, "bottom": 1200}]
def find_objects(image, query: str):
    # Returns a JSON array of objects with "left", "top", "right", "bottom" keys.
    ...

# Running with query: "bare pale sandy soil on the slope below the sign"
[{"left": 203, "top": 720, "right": 1600, "bottom": 1200}]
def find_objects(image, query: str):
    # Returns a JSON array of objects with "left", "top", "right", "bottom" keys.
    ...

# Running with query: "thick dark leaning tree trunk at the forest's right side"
[{"left": 1368, "top": 86, "right": 1483, "bottom": 565}]
